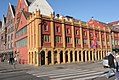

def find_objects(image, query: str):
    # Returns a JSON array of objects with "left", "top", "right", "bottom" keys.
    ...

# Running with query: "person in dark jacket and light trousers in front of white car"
[{"left": 107, "top": 53, "right": 116, "bottom": 78}]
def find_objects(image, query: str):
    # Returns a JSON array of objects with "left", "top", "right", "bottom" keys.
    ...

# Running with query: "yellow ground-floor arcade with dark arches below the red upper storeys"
[{"left": 28, "top": 48, "right": 111, "bottom": 66}]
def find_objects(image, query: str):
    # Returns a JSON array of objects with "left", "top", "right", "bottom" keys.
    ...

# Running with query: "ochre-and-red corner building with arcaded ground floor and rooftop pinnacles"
[{"left": 27, "top": 11, "right": 112, "bottom": 66}]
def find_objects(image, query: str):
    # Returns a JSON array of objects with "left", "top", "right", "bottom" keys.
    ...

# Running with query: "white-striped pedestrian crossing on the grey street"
[{"left": 27, "top": 69, "right": 104, "bottom": 80}]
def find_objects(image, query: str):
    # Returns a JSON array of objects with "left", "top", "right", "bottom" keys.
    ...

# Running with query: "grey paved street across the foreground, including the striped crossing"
[{"left": 0, "top": 61, "right": 117, "bottom": 80}]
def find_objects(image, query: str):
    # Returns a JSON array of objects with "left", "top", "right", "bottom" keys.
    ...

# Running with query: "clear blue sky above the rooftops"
[{"left": 0, "top": 0, "right": 119, "bottom": 22}]
